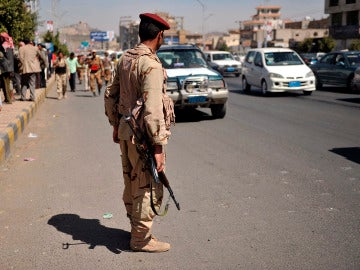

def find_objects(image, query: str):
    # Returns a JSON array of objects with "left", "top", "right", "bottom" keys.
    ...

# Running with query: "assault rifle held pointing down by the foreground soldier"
[{"left": 124, "top": 114, "right": 180, "bottom": 211}]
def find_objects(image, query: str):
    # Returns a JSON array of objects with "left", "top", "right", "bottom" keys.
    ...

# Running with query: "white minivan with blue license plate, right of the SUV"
[{"left": 241, "top": 48, "right": 315, "bottom": 95}]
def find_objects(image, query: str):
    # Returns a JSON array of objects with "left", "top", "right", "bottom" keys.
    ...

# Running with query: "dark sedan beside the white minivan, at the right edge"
[{"left": 311, "top": 51, "right": 360, "bottom": 89}]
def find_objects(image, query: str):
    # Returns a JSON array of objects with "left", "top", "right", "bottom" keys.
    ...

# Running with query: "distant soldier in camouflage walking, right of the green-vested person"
[{"left": 88, "top": 50, "right": 104, "bottom": 97}]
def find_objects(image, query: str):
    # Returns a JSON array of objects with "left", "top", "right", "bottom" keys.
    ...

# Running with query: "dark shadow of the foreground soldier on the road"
[{"left": 48, "top": 214, "right": 130, "bottom": 254}]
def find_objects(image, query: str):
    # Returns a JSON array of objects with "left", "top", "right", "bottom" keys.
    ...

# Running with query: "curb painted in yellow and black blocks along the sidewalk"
[{"left": 0, "top": 76, "right": 55, "bottom": 164}]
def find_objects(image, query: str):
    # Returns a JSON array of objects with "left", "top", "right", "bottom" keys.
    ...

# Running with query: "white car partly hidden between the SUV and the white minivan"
[{"left": 204, "top": 51, "right": 241, "bottom": 77}]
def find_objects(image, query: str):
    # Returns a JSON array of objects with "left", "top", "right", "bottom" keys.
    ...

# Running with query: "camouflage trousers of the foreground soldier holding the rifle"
[{"left": 120, "top": 140, "right": 163, "bottom": 244}]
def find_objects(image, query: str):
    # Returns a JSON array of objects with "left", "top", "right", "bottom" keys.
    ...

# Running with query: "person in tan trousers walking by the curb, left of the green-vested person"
[{"left": 54, "top": 51, "right": 70, "bottom": 100}]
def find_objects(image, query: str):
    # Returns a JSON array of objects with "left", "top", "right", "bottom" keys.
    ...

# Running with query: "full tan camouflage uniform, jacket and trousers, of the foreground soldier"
[{"left": 105, "top": 44, "right": 175, "bottom": 251}]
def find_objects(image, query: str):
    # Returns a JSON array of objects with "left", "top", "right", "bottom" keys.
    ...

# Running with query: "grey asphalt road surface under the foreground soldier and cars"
[{"left": 0, "top": 78, "right": 360, "bottom": 270}]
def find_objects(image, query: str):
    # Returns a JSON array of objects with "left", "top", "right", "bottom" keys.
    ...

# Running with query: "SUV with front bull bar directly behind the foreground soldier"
[{"left": 157, "top": 45, "right": 229, "bottom": 118}]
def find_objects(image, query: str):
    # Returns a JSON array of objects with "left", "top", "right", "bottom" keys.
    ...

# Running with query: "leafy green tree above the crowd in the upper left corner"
[{"left": 0, "top": 0, "right": 38, "bottom": 43}]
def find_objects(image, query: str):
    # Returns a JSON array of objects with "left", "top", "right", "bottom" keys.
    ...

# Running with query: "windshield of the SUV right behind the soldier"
[{"left": 157, "top": 50, "right": 206, "bottom": 69}]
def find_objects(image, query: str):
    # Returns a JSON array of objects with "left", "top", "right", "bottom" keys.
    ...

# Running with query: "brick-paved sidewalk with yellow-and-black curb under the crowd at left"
[{"left": 0, "top": 75, "right": 55, "bottom": 164}]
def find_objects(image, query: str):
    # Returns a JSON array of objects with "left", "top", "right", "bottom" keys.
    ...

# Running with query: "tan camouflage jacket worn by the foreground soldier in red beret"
[{"left": 104, "top": 44, "right": 175, "bottom": 145}]
